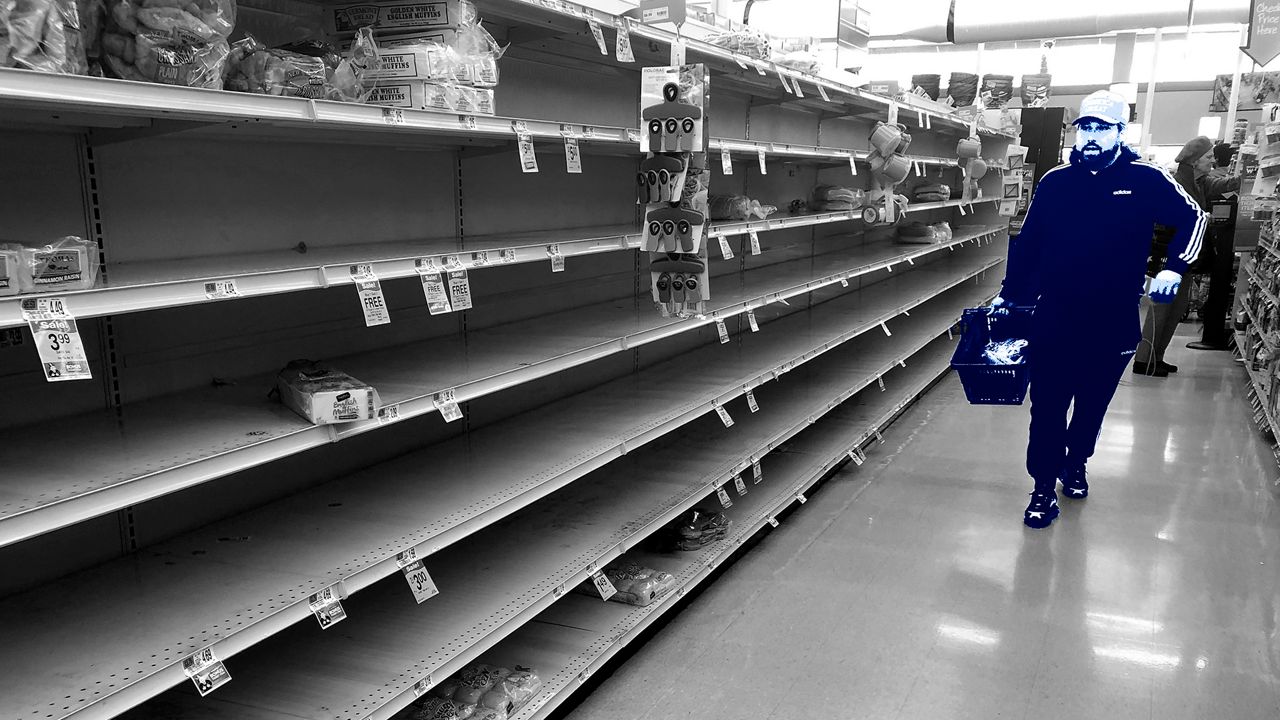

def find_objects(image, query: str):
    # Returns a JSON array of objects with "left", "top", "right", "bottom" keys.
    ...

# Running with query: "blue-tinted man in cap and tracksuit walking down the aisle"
[{"left": 992, "top": 90, "right": 1207, "bottom": 528}]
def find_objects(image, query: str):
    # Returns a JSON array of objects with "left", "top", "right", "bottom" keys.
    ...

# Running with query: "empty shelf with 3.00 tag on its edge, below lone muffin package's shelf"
[{"left": 0, "top": 247, "right": 1002, "bottom": 720}]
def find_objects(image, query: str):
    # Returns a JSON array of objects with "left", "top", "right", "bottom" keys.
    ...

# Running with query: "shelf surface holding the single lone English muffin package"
[{"left": 0, "top": 225, "right": 1002, "bottom": 544}]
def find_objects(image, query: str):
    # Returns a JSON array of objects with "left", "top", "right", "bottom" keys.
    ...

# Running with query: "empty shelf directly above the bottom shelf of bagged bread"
[{"left": 112, "top": 283, "right": 995, "bottom": 720}]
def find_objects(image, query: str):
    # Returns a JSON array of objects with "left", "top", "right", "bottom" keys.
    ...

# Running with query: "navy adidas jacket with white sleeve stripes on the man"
[{"left": 1001, "top": 145, "right": 1208, "bottom": 352}]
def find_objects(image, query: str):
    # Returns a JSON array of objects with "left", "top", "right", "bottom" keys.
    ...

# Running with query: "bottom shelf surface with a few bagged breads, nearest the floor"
[{"left": 455, "top": 336, "right": 955, "bottom": 720}]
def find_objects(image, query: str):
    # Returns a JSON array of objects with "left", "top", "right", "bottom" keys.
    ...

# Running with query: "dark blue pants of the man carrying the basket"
[{"left": 1027, "top": 348, "right": 1130, "bottom": 492}]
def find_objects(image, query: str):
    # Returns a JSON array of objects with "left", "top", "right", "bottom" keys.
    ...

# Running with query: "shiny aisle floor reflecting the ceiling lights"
[{"left": 568, "top": 325, "right": 1280, "bottom": 720}]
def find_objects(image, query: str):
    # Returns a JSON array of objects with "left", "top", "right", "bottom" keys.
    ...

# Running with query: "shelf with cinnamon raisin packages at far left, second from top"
[{"left": 0, "top": 199, "right": 995, "bottom": 328}]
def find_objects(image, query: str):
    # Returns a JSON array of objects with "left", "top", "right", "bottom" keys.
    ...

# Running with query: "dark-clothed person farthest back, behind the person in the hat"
[{"left": 1187, "top": 142, "right": 1240, "bottom": 350}]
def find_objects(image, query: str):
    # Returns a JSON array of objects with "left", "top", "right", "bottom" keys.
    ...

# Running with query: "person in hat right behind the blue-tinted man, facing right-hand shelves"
[{"left": 1133, "top": 136, "right": 1240, "bottom": 378}]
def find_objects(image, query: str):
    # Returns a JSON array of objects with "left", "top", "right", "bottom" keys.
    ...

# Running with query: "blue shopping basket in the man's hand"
[{"left": 951, "top": 302, "right": 1032, "bottom": 405}]
